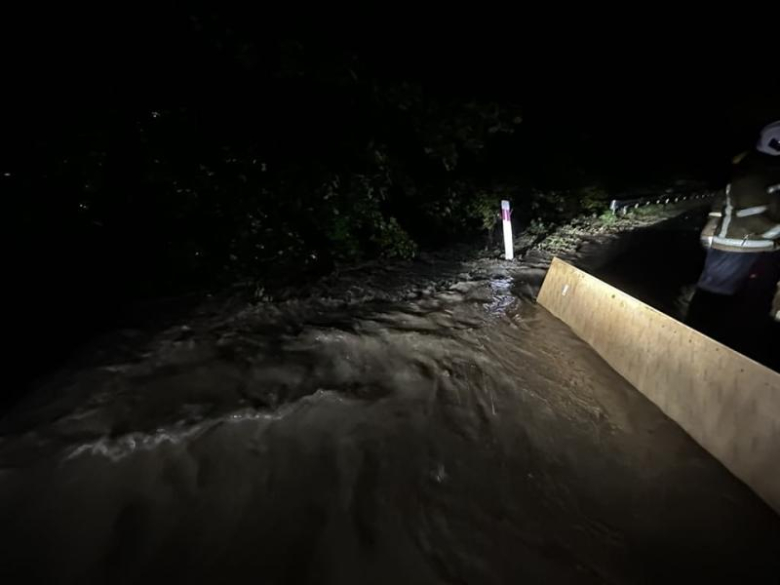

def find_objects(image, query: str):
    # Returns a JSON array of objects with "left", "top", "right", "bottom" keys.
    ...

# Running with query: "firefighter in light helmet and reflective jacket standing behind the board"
[{"left": 688, "top": 121, "right": 780, "bottom": 368}]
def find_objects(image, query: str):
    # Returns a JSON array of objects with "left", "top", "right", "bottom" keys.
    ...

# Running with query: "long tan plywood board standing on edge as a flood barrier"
[{"left": 538, "top": 259, "right": 780, "bottom": 513}]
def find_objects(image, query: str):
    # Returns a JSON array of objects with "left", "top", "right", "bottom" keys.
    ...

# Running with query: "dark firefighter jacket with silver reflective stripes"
[{"left": 702, "top": 152, "right": 780, "bottom": 252}]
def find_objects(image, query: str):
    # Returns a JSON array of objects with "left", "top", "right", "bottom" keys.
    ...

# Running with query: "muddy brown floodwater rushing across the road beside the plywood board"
[{"left": 0, "top": 230, "right": 780, "bottom": 584}]
